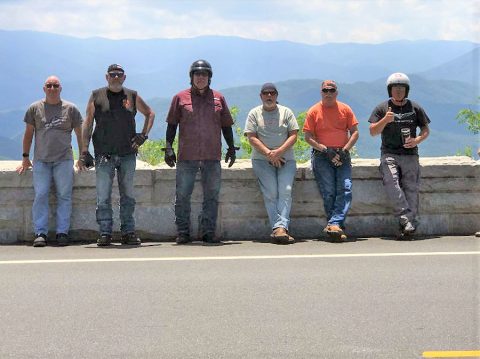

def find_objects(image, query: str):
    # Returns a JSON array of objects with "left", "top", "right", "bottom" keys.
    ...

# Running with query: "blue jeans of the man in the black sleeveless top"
[{"left": 95, "top": 153, "right": 137, "bottom": 235}]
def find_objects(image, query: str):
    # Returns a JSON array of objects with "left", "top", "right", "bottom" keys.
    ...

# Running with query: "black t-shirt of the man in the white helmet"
[{"left": 368, "top": 100, "right": 430, "bottom": 155}]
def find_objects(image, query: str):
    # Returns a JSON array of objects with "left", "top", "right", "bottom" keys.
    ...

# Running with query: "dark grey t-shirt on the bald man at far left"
[{"left": 24, "top": 100, "right": 82, "bottom": 162}]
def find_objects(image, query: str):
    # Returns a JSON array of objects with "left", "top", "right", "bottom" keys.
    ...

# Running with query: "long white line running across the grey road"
[{"left": 0, "top": 251, "right": 480, "bottom": 265}]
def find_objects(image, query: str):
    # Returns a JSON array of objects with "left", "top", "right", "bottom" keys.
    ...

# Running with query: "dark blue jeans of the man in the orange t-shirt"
[{"left": 312, "top": 152, "right": 352, "bottom": 228}]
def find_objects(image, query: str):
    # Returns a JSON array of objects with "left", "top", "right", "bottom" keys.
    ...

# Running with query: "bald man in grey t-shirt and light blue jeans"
[{"left": 17, "top": 76, "right": 82, "bottom": 247}]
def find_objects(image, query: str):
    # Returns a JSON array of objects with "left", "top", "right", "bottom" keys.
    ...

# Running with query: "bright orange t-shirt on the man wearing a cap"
[{"left": 303, "top": 101, "right": 358, "bottom": 147}]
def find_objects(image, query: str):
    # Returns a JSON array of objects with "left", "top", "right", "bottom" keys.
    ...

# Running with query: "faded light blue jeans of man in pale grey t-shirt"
[{"left": 252, "top": 160, "right": 297, "bottom": 229}]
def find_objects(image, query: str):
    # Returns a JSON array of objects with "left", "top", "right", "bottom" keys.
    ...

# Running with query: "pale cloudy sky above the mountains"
[{"left": 0, "top": 0, "right": 480, "bottom": 44}]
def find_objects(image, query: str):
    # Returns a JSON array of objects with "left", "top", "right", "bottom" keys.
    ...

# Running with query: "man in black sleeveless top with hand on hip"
[{"left": 80, "top": 64, "right": 155, "bottom": 246}]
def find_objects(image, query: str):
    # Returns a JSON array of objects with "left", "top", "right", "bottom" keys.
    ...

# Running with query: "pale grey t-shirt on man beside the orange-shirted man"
[{"left": 244, "top": 105, "right": 299, "bottom": 161}]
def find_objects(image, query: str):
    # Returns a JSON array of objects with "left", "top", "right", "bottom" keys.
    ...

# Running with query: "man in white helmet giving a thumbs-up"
[{"left": 368, "top": 73, "right": 430, "bottom": 238}]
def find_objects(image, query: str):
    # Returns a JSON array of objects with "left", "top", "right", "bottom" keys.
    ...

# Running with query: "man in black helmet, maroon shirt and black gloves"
[{"left": 165, "top": 60, "right": 238, "bottom": 245}]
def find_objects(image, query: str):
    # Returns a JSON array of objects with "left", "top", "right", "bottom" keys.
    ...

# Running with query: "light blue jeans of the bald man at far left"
[{"left": 32, "top": 160, "right": 73, "bottom": 234}]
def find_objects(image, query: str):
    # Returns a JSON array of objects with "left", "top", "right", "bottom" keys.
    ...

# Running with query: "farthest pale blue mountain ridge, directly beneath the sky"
[{"left": 0, "top": 30, "right": 478, "bottom": 110}]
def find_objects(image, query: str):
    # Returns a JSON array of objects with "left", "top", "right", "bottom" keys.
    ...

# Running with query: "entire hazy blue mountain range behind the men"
[{"left": 0, "top": 30, "right": 480, "bottom": 159}]
